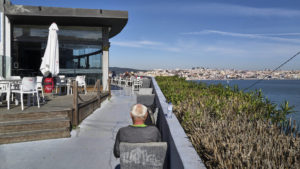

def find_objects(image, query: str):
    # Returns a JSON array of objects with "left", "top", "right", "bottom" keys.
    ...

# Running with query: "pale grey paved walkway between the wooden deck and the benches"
[{"left": 0, "top": 86, "right": 136, "bottom": 169}]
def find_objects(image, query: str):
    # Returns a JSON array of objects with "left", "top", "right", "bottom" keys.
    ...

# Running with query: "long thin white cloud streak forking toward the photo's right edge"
[{"left": 183, "top": 30, "right": 300, "bottom": 43}]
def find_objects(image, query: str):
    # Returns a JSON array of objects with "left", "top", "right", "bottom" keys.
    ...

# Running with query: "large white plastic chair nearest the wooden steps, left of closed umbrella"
[{"left": 11, "top": 77, "right": 40, "bottom": 111}]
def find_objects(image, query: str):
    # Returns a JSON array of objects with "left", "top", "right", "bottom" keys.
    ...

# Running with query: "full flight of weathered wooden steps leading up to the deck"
[{"left": 0, "top": 111, "right": 70, "bottom": 144}]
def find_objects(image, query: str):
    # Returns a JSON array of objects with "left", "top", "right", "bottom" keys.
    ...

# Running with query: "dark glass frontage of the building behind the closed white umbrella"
[{"left": 12, "top": 25, "right": 102, "bottom": 85}]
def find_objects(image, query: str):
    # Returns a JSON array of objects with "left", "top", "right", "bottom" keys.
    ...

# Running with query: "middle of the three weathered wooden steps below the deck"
[{"left": 0, "top": 118, "right": 70, "bottom": 134}]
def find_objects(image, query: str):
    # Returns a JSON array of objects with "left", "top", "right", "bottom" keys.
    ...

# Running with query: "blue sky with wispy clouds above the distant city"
[{"left": 12, "top": 0, "right": 300, "bottom": 70}]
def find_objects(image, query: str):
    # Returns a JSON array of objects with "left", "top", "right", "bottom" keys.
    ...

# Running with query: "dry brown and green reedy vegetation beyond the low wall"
[{"left": 156, "top": 77, "right": 300, "bottom": 168}]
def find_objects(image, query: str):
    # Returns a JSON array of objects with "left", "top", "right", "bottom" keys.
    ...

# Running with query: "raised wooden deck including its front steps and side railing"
[{"left": 0, "top": 92, "right": 109, "bottom": 144}]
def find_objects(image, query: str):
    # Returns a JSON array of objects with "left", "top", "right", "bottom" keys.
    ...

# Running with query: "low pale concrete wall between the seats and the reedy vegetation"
[{"left": 151, "top": 78, "right": 206, "bottom": 169}]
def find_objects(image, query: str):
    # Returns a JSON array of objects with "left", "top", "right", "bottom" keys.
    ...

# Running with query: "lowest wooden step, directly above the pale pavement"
[{"left": 0, "top": 129, "right": 71, "bottom": 144}]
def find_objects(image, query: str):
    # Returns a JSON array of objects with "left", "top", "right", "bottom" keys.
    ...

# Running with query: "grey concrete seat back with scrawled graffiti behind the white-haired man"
[{"left": 120, "top": 142, "right": 167, "bottom": 169}]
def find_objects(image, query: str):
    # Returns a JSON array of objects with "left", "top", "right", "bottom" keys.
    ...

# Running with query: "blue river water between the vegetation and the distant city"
[{"left": 197, "top": 80, "right": 300, "bottom": 124}]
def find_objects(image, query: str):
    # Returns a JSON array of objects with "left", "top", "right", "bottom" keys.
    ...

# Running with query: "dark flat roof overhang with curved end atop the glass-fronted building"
[{"left": 4, "top": 4, "right": 128, "bottom": 38}]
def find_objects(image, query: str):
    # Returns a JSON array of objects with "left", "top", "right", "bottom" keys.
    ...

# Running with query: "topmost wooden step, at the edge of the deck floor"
[{"left": 0, "top": 110, "right": 69, "bottom": 122}]
